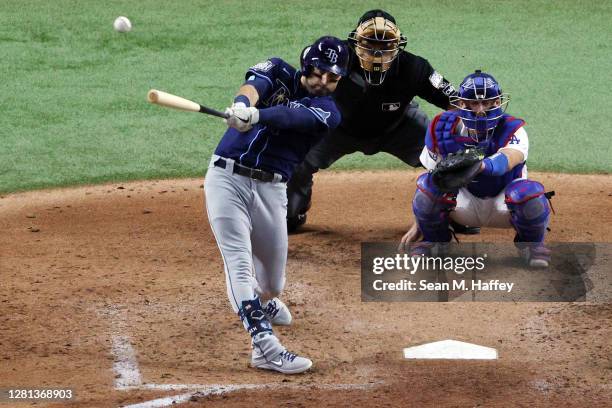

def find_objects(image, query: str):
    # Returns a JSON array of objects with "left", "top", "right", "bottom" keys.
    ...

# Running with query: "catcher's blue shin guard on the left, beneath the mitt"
[{"left": 412, "top": 173, "right": 457, "bottom": 242}]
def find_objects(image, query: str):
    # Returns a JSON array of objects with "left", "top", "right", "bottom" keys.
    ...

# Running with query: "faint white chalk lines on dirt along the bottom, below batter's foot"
[{"left": 122, "top": 383, "right": 379, "bottom": 408}]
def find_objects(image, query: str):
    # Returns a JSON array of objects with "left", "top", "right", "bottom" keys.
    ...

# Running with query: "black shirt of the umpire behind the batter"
[{"left": 334, "top": 50, "right": 456, "bottom": 139}]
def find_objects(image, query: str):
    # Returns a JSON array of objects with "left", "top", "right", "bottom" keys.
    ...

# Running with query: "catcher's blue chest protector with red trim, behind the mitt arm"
[{"left": 426, "top": 111, "right": 525, "bottom": 198}]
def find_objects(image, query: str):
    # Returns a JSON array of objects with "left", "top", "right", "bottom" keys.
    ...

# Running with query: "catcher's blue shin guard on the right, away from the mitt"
[{"left": 505, "top": 179, "right": 550, "bottom": 242}]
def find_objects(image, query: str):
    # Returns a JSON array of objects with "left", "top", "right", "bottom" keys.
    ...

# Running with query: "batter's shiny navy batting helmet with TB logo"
[{"left": 300, "top": 36, "right": 349, "bottom": 76}]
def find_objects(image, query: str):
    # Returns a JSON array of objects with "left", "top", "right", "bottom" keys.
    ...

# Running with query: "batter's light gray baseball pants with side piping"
[{"left": 204, "top": 155, "right": 287, "bottom": 313}]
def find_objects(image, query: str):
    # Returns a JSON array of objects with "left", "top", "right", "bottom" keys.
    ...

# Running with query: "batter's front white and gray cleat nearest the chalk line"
[{"left": 251, "top": 333, "right": 312, "bottom": 374}]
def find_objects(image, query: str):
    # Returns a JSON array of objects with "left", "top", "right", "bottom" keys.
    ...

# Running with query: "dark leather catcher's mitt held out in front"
[{"left": 431, "top": 148, "right": 484, "bottom": 193}]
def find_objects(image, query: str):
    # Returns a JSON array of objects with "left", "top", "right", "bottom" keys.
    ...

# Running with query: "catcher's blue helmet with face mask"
[{"left": 451, "top": 70, "right": 510, "bottom": 140}]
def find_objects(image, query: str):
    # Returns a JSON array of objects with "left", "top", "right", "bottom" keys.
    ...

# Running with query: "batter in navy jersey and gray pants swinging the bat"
[{"left": 204, "top": 37, "right": 348, "bottom": 374}]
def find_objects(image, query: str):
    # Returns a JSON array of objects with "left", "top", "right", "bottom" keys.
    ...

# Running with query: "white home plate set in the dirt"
[{"left": 404, "top": 340, "right": 497, "bottom": 360}]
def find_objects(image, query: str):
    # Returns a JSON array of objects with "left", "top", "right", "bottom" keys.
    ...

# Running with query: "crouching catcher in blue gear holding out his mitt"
[{"left": 401, "top": 71, "right": 551, "bottom": 267}]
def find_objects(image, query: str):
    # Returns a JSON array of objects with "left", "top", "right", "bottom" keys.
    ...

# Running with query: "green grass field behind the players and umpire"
[{"left": 0, "top": 0, "right": 612, "bottom": 192}]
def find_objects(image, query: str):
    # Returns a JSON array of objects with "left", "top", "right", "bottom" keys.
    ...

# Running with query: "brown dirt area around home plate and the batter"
[{"left": 0, "top": 171, "right": 612, "bottom": 407}]
